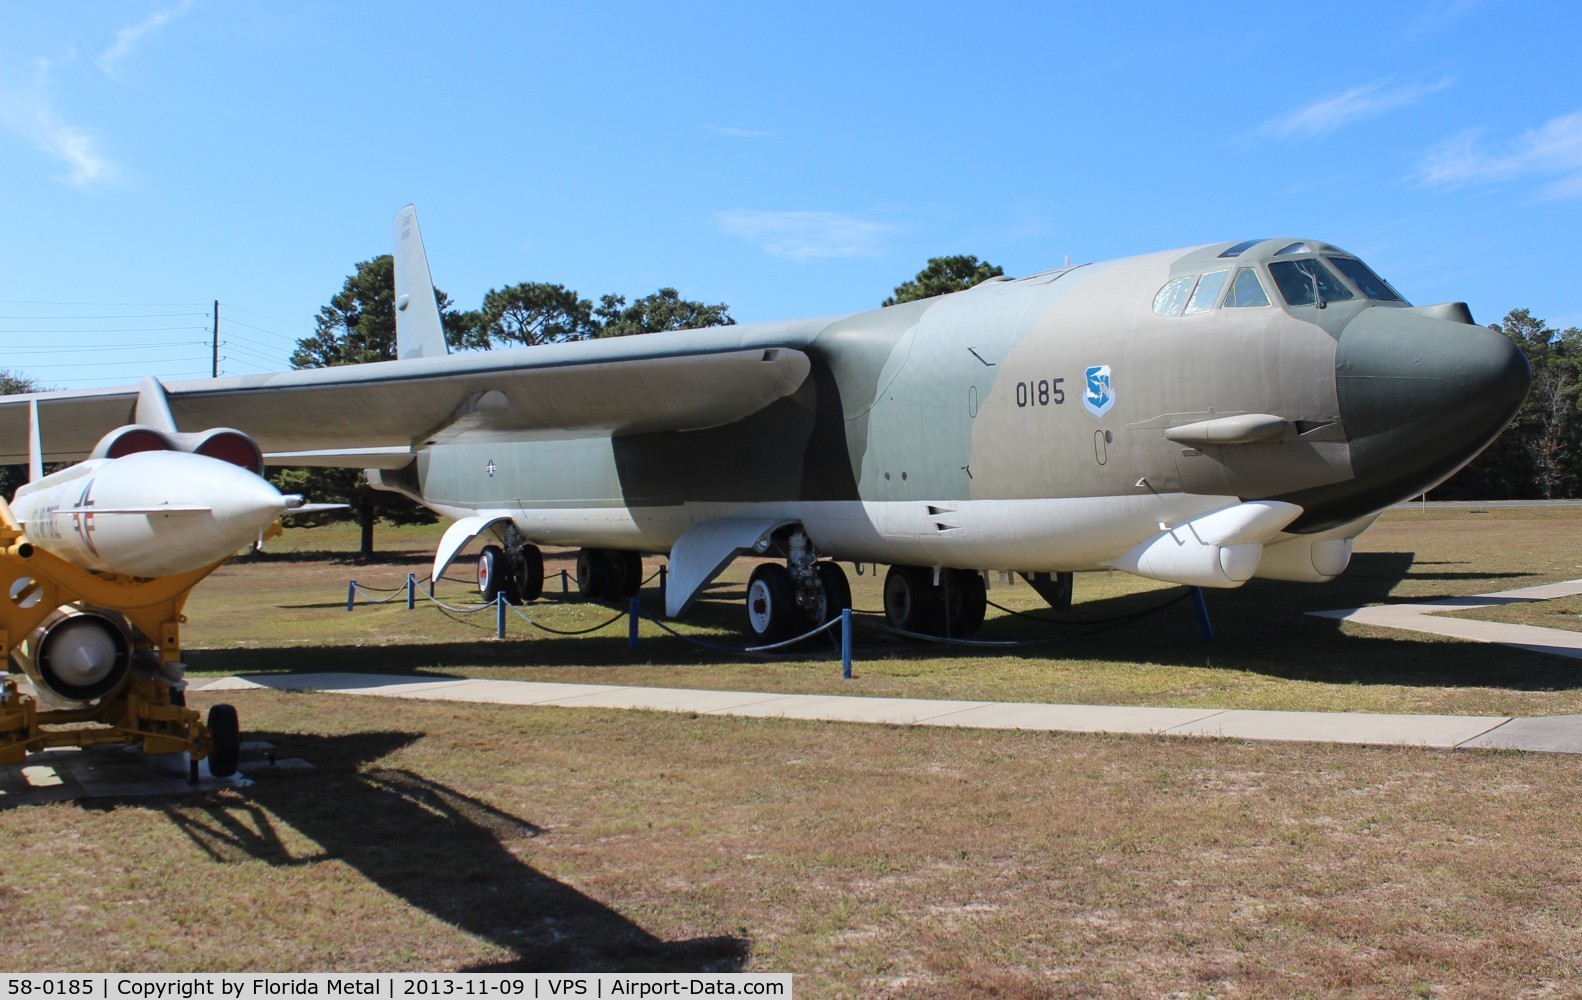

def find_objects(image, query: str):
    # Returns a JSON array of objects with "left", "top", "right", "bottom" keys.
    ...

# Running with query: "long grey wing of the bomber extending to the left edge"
[{"left": 0, "top": 321, "right": 823, "bottom": 468}]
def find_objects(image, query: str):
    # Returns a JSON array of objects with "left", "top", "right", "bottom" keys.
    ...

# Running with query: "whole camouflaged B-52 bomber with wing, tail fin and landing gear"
[{"left": 0, "top": 213, "right": 1530, "bottom": 641}]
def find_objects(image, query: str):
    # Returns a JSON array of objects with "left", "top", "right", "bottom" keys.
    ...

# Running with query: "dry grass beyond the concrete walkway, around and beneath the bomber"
[{"left": 188, "top": 508, "right": 1582, "bottom": 715}]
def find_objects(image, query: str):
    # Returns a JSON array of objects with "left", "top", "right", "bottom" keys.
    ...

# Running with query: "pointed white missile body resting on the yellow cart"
[{"left": 11, "top": 451, "right": 302, "bottom": 578}]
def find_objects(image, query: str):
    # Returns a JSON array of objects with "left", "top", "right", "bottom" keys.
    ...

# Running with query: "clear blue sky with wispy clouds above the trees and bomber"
[{"left": 0, "top": 0, "right": 1582, "bottom": 388}]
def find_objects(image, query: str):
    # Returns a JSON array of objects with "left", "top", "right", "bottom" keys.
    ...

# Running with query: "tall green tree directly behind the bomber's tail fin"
[{"left": 280, "top": 253, "right": 446, "bottom": 560}]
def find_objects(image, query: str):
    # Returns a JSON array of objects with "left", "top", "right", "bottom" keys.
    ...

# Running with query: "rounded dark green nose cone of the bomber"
[{"left": 1335, "top": 309, "right": 1531, "bottom": 516}]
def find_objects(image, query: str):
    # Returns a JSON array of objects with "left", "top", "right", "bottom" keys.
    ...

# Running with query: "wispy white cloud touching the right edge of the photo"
[{"left": 1417, "top": 111, "right": 1582, "bottom": 201}]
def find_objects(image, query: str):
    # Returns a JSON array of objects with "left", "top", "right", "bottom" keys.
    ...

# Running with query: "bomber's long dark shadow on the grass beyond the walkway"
[{"left": 188, "top": 552, "right": 1582, "bottom": 690}]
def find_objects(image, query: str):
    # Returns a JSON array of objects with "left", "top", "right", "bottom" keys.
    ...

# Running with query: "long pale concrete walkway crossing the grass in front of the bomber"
[{"left": 202, "top": 674, "right": 1582, "bottom": 753}]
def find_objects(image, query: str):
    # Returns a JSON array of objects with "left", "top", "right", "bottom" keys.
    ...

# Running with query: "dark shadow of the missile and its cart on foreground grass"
[{"left": 118, "top": 733, "right": 748, "bottom": 972}]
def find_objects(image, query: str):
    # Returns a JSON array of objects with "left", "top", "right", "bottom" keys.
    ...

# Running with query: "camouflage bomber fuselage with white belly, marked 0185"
[{"left": 408, "top": 241, "right": 1528, "bottom": 579}]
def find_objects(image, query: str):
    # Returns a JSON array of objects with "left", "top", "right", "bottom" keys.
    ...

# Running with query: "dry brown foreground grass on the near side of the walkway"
[{"left": 9, "top": 693, "right": 1582, "bottom": 997}]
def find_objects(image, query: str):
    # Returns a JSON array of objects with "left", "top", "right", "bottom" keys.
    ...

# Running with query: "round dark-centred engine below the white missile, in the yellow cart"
[{"left": 11, "top": 604, "right": 131, "bottom": 709}]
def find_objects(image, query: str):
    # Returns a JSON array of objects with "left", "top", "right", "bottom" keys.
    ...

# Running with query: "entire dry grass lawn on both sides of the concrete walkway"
[{"left": 0, "top": 508, "right": 1582, "bottom": 997}]
